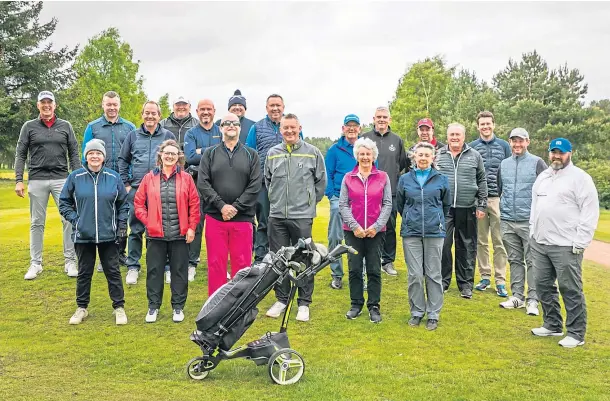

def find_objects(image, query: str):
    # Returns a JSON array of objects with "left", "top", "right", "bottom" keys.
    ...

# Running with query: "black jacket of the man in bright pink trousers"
[{"left": 197, "top": 142, "right": 263, "bottom": 222}]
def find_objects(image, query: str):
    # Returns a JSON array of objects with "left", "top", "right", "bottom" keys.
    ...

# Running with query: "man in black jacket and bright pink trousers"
[{"left": 197, "top": 113, "right": 262, "bottom": 295}]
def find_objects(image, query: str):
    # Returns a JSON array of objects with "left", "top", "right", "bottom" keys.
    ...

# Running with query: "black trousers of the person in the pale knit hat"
[{"left": 74, "top": 242, "right": 125, "bottom": 309}]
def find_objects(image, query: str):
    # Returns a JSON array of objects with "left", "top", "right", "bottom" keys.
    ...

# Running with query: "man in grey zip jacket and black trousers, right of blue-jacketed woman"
[{"left": 436, "top": 123, "right": 487, "bottom": 299}]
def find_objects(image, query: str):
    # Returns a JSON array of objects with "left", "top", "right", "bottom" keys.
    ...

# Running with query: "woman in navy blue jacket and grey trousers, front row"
[{"left": 396, "top": 142, "right": 451, "bottom": 330}]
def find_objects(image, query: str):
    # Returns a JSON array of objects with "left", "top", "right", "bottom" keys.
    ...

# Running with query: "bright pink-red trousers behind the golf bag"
[{"left": 205, "top": 215, "right": 252, "bottom": 295}]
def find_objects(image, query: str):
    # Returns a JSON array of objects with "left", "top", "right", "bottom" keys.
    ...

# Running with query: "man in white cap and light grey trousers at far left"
[{"left": 15, "top": 91, "right": 81, "bottom": 280}]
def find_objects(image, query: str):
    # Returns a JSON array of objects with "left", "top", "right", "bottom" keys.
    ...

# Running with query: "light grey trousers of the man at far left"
[{"left": 28, "top": 178, "right": 76, "bottom": 265}]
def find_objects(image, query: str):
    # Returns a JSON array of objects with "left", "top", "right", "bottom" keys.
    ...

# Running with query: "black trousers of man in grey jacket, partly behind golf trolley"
[{"left": 267, "top": 217, "right": 314, "bottom": 306}]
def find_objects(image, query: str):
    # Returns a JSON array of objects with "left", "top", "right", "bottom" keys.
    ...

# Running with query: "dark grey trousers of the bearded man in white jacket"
[{"left": 530, "top": 239, "right": 587, "bottom": 341}]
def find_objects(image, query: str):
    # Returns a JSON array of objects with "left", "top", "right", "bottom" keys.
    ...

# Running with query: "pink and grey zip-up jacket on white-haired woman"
[{"left": 339, "top": 166, "right": 392, "bottom": 232}]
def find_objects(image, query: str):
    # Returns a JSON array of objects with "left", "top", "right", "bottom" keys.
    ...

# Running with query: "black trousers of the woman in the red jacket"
[{"left": 146, "top": 238, "right": 189, "bottom": 309}]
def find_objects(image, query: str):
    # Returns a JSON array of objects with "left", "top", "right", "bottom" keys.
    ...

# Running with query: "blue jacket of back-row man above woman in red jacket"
[{"left": 119, "top": 124, "right": 176, "bottom": 188}]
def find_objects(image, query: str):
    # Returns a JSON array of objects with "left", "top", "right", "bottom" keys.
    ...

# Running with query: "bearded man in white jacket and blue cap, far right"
[{"left": 530, "top": 138, "right": 599, "bottom": 348}]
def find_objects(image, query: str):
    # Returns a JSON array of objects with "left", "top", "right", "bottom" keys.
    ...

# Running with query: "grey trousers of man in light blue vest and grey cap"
[{"left": 500, "top": 220, "right": 538, "bottom": 301}]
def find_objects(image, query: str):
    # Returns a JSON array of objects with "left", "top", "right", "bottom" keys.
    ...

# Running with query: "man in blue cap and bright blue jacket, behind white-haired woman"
[{"left": 325, "top": 114, "right": 360, "bottom": 290}]
